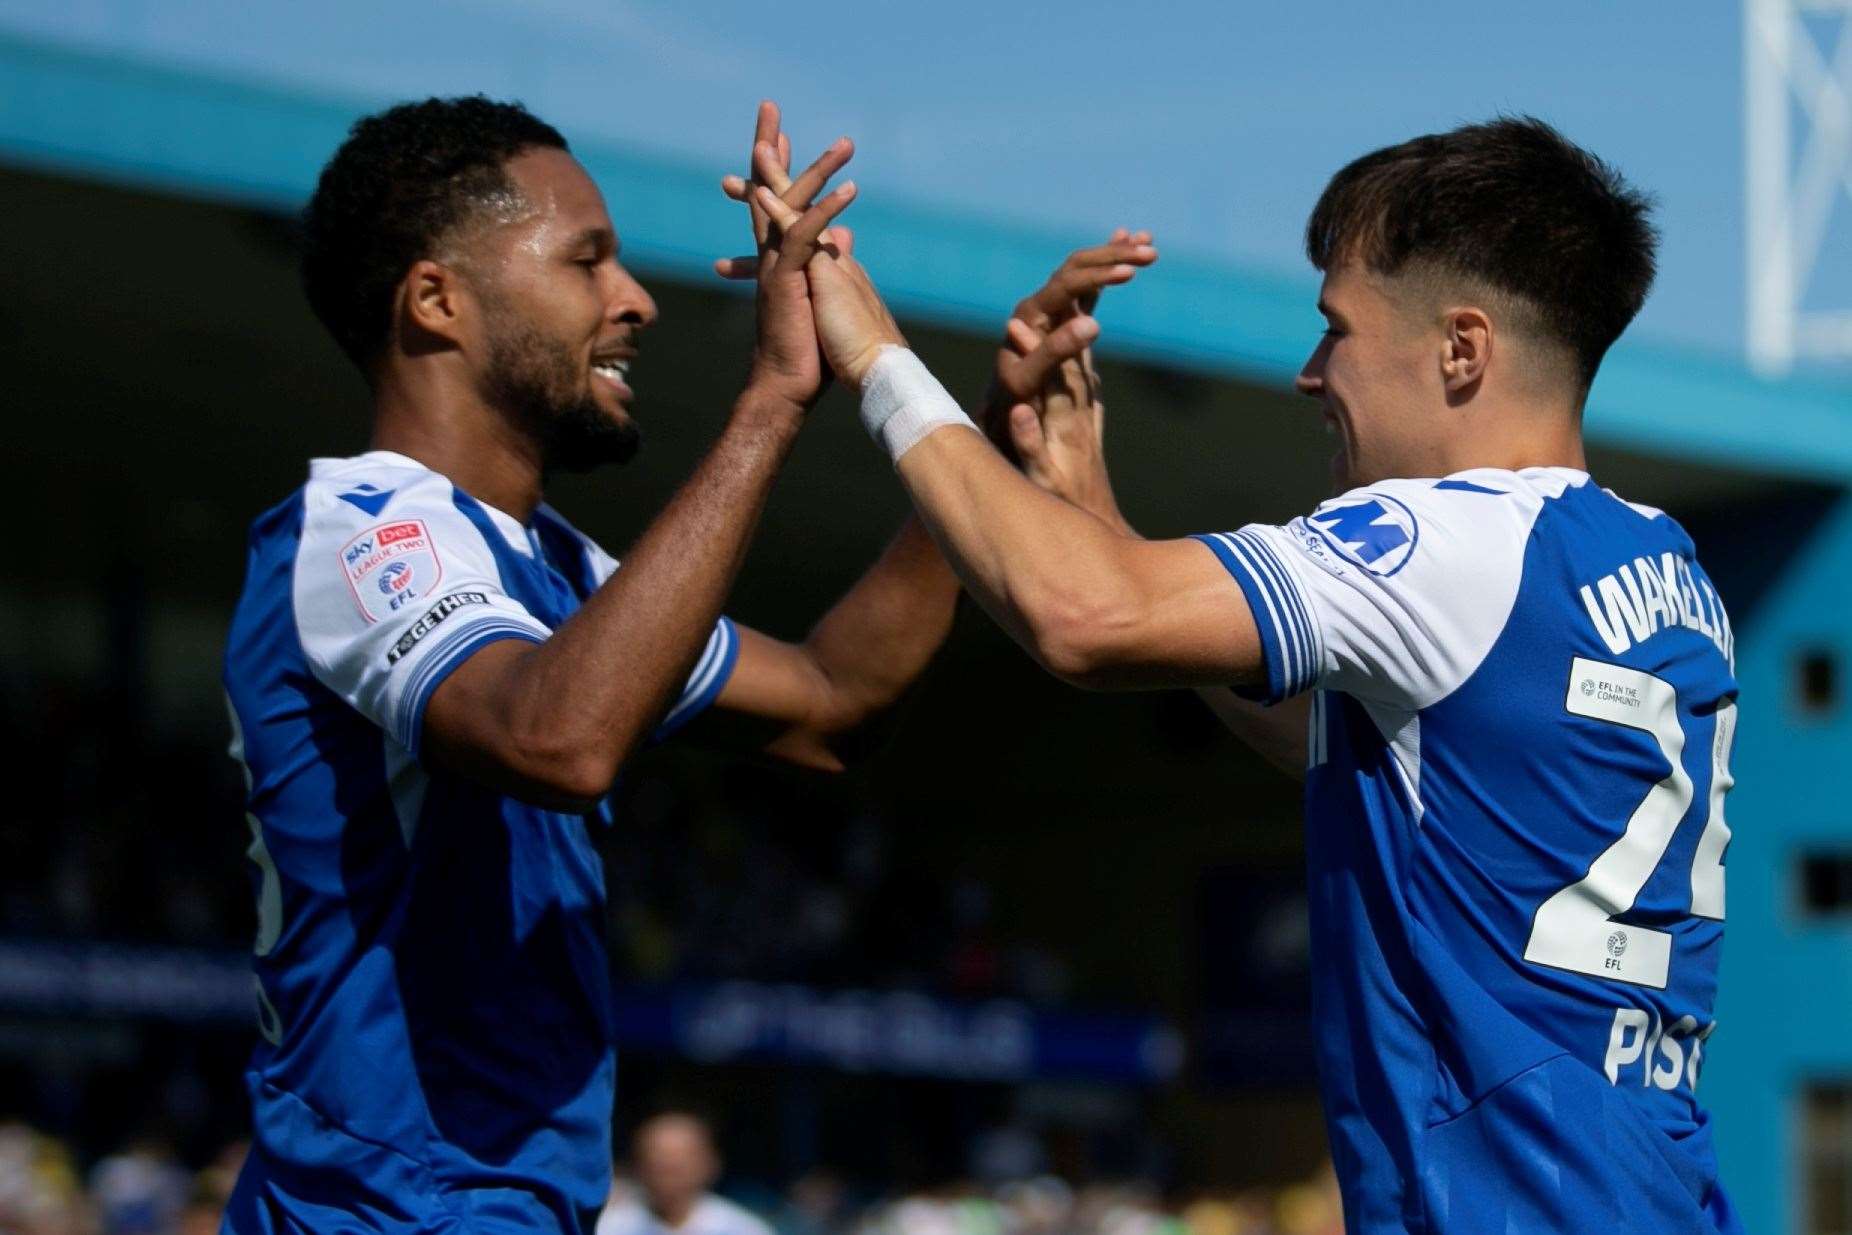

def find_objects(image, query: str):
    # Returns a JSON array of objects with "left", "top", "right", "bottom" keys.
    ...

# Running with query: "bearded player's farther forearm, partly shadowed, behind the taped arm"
[{"left": 804, "top": 518, "right": 957, "bottom": 733}]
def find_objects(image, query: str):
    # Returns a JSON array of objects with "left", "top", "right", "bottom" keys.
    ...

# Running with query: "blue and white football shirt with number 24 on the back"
[{"left": 1202, "top": 468, "right": 1739, "bottom": 1235}]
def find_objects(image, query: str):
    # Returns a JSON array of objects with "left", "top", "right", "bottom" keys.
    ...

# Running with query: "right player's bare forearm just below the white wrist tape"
[{"left": 898, "top": 428, "right": 1139, "bottom": 681}]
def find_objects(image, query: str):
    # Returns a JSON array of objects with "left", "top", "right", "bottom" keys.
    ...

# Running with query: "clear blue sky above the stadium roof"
[{"left": 14, "top": 0, "right": 1852, "bottom": 366}]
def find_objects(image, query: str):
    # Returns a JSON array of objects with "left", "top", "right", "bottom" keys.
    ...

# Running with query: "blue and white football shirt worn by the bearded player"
[{"left": 226, "top": 452, "right": 737, "bottom": 1235}]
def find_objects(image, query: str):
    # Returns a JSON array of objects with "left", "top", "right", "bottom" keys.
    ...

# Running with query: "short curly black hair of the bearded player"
[{"left": 302, "top": 94, "right": 567, "bottom": 372}]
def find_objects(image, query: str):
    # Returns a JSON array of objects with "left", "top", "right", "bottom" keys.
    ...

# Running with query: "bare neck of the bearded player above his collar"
[{"left": 372, "top": 364, "right": 543, "bottom": 522}]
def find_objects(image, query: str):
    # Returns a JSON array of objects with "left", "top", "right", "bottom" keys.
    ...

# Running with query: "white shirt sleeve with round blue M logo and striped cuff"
[{"left": 1198, "top": 472, "right": 1545, "bottom": 709}]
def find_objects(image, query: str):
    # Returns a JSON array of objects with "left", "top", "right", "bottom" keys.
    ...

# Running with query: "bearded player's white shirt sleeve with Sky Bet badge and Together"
[{"left": 293, "top": 472, "right": 552, "bottom": 755}]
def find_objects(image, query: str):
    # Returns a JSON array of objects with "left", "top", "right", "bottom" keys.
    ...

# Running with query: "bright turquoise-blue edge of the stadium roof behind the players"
[{"left": 0, "top": 35, "right": 1852, "bottom": 483}]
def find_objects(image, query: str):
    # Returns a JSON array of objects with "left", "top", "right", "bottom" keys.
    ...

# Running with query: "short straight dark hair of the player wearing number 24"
[{"left": 1306, "top": 117, "right": 1658, "bottom": 393}]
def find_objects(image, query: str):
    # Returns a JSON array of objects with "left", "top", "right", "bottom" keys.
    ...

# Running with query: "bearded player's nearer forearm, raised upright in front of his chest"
[{"left": 481, "top": 391, "right": 802, "bottom": 798}]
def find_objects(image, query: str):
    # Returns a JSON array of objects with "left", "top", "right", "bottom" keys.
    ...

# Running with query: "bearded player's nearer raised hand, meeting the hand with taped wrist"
[{"left": 715, "top": 100, "right": 856, "bottom": 407}]
